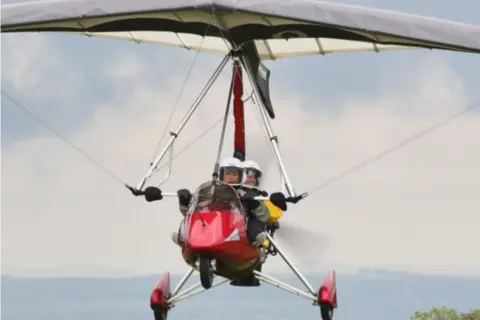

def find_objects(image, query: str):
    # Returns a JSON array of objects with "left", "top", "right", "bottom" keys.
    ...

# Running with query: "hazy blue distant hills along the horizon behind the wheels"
[{"left": 1, "top": 269, "right": 480, "bottom": 320}]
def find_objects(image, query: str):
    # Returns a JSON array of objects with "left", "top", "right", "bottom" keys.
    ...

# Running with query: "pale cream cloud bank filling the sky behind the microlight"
[{"left": 2, "top": 29, "right": 480, "bottom": 274}]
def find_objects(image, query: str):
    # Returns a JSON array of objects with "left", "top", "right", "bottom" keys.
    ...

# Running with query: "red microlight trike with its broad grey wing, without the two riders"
[{"left": 1, "top": 0, "right": 480, "bottom": 320}]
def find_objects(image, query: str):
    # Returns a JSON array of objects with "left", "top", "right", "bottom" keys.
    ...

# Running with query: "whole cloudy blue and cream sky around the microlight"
[{"left": 1, "top": 0, "right": 480, "bottom": 276}]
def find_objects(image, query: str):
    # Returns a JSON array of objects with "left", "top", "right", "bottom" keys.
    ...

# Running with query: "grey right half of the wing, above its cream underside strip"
[{"left": 228, "top": 0, "right": 480, "bottom": 53}]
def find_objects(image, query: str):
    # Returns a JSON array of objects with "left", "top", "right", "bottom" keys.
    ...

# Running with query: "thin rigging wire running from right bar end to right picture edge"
[{"left": 306, "top": 102, "right": 480, "bottom": 195}]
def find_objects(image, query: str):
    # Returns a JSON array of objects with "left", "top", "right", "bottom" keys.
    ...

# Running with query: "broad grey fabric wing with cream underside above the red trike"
[{"left": 2, "top": 0, "right": 480, "bottom": 60}]
